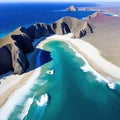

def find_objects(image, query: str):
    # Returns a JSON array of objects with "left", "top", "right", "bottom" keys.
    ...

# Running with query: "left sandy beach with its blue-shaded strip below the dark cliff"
[{"left": 0, "top": 38, "right": 42, "bottom": 107}]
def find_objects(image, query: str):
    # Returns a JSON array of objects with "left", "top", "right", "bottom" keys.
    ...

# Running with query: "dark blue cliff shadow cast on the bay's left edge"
[{"left": 26, "top": 48, "right": 53, "bottom": 72}]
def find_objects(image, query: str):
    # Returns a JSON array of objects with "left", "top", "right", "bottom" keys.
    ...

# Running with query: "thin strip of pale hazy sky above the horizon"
[{"left": 0, "top": 0, "right": 120, "bottom": 2}]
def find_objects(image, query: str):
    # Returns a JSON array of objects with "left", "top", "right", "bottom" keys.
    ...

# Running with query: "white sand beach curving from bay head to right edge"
[{"left": 39, "top": 33, "right": 120, "bottom": 82}]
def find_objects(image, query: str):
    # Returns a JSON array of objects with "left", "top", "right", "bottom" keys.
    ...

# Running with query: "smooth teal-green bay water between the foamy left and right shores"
[{"left": 39, "top": 41, "right": 120, "bottom": 120}]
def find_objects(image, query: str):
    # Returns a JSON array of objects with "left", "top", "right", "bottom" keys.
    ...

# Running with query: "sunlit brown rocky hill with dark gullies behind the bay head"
[{"left": 51, "top": 16, "right": 93, "bottom": 38}]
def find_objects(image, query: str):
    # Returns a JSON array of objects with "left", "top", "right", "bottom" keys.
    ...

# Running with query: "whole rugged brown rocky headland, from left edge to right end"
[{"left": 0, "top": 16, "right": 93, "bottom": 75}]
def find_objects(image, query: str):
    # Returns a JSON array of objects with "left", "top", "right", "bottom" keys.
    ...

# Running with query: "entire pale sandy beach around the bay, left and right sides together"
[{"left": 0, "top": 33, "right": 120, "bottom": 107}]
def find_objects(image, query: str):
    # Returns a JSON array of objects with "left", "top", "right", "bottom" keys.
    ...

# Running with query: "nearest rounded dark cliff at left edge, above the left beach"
[{"left": 0, "top": 44, "right": 29, "bottom": 75}]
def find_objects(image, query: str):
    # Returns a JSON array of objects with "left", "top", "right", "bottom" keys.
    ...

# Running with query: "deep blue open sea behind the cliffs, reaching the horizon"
[{"left": 0, "top": 3, "right": 96, "bottom": 37}]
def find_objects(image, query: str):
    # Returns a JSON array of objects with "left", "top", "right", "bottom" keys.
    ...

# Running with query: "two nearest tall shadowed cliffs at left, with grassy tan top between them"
[{"left": 0, "top": 27, "right": 34, "bottom": 75}]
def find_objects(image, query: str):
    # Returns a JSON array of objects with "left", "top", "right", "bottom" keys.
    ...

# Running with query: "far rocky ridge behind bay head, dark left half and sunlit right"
[{"left": 27, "top": 16, "right": 93, "bottom": 39}]
